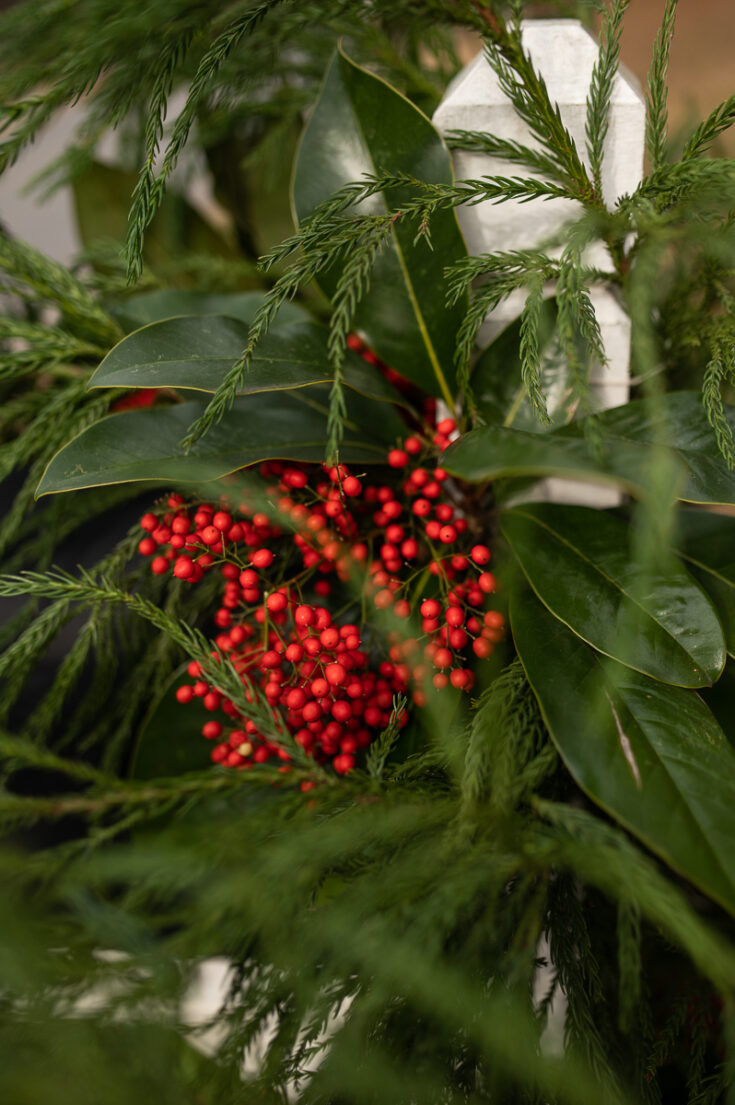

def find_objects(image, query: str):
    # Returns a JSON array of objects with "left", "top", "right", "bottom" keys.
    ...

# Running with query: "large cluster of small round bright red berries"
[{"left": 138, "top": 419, "right": 504, "bottom": 772}]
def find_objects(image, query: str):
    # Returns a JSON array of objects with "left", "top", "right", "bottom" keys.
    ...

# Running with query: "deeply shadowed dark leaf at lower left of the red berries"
[{"left": 130, "top": 663, "right": 212, "bottom": 779}]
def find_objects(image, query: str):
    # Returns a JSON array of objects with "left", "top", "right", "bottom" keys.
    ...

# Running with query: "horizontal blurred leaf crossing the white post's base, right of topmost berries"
[{"left": 442, "top": 425, "right": 685, "bottom": 497}]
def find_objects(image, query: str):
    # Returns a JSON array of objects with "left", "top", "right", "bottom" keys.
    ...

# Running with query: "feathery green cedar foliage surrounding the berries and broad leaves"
[{"left": 0, "top": 0, "right": 735, "bottom": 1105}]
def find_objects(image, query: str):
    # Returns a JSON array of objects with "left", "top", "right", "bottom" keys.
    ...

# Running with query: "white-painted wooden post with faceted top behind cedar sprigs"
[{"left": 433, "top": 19, "right": 645, "bottom": 506}]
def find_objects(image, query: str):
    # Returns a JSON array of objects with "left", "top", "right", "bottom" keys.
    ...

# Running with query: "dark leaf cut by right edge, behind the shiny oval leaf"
[{"left": 679, "top": 511, "right": 735, "bottom": 656}]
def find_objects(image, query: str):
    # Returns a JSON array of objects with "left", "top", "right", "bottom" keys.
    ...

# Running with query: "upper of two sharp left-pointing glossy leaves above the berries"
[{"left": 90, "top": 315, "right": 402, "bottom": 411}]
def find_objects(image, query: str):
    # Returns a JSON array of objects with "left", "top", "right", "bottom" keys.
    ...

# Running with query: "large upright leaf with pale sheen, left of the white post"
[{"left": 293, "top": 52, "right": 466, "bottom": 406}]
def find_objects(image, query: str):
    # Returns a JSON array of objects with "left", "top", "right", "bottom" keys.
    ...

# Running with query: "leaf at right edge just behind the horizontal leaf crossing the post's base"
[{"left": 556, "top": 391, "right": 735, "bottom": 504}]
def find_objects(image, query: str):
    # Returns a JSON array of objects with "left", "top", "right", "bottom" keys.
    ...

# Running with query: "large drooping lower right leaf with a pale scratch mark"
[{"left": 511, "top": 590, "right": 735, "bottom": 912}]
